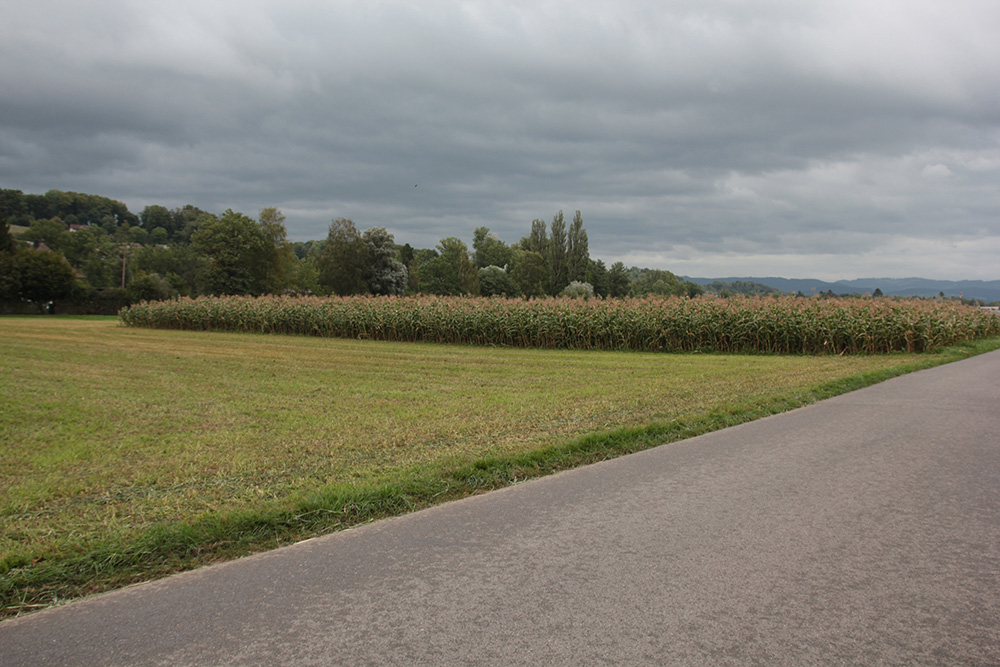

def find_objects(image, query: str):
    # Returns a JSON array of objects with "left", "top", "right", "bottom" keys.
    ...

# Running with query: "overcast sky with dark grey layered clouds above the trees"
[{"left": 0, "top": 0, "right": 1000, "bottom": 280}]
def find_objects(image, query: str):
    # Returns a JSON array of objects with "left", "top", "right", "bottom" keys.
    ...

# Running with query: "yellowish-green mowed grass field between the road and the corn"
[{"left": 0, "top": 317, "right": 996, "bottom": 615}]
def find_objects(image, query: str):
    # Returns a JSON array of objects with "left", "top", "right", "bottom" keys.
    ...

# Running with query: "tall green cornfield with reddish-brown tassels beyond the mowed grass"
[{"left": 119, "top": 296, "right": 1000, "bottom": 354}]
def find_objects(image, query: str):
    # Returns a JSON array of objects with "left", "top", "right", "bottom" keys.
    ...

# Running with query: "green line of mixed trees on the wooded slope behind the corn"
[{"left": 0, "top": 190, "right": 701, "bottom": 311}]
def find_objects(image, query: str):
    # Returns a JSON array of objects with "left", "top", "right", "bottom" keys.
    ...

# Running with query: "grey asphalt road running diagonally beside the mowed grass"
[{"left": 0, "top": 352, "right": 1000, "bottom": 666}]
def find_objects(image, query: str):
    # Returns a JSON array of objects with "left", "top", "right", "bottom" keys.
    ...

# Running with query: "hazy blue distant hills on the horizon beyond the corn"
[{"left": 682, "top": 276, "right": 1000, "bottom": 303}]
